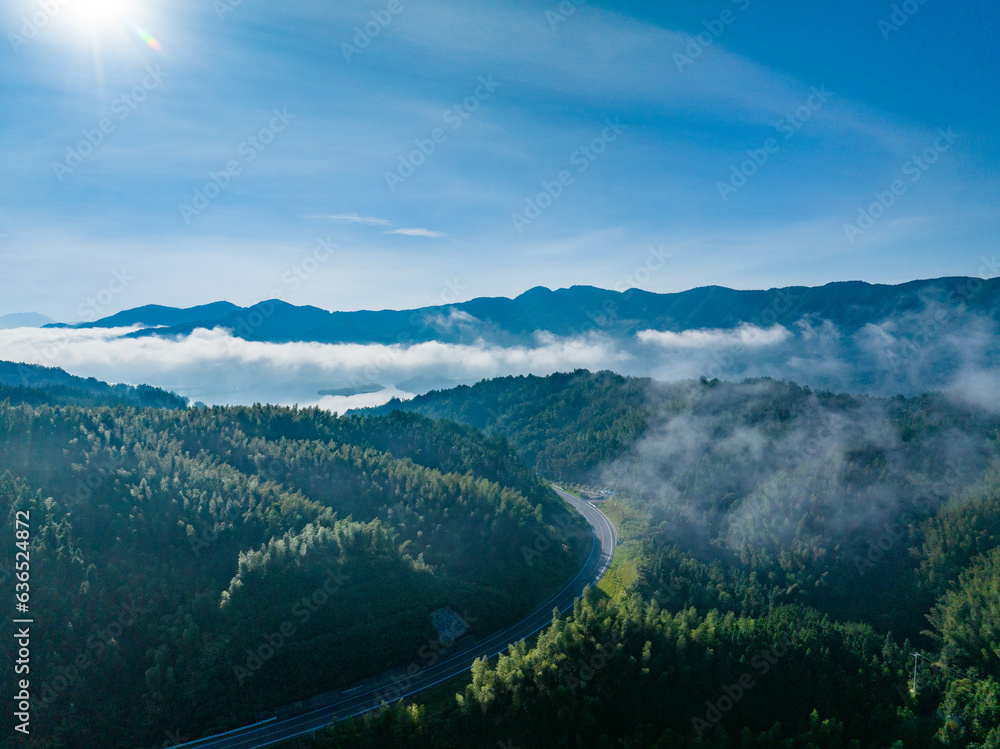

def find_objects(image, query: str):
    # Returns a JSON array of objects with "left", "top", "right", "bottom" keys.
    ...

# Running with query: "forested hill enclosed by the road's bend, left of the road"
[{"left": 0, "top": 391, "right": 590, "bottom": 747}]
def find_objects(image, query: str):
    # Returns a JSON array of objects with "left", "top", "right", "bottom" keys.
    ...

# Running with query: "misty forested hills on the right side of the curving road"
[{"left": 346, "top": 371, "right": 1000, "bottom": 749}]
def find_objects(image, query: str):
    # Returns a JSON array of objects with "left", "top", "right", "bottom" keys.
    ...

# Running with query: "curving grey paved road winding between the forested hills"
[{"left": 167, "top": 487, "right": 617, "bottom": 749}]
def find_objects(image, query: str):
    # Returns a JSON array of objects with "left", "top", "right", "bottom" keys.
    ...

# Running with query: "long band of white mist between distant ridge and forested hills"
[{"left": 0, "top": 305, "right": 1000, "bottom": 408}]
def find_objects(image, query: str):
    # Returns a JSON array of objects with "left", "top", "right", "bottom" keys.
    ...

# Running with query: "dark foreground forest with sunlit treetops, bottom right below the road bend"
[{"left": 289, "top": 584, "right": 1000, "bottom": 749}]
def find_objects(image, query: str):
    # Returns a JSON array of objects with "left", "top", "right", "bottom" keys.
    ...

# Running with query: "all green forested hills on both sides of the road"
[{"left": 0, "top": 371, "right": 1000, "bottom": 749}]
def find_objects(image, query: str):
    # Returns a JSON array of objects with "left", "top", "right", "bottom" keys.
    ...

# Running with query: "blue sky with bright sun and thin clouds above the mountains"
[{"left": 0, "top": 0, "right": 1000, "bottom": 320}]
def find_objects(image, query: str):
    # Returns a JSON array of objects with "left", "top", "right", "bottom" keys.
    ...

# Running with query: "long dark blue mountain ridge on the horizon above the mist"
[{"left": 50, "top": 277, "right": 1000, "bottom": 344}]
